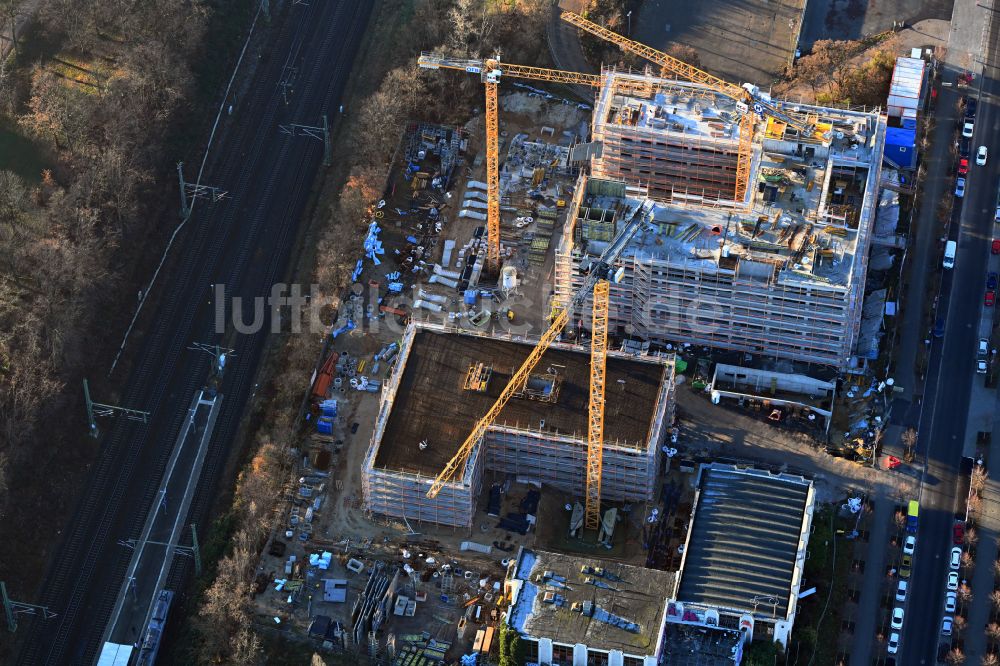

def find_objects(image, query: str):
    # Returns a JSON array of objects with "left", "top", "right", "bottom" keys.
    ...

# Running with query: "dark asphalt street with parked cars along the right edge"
[{"left": 898, "top": 7, "right": 1000, "bottom": 664}]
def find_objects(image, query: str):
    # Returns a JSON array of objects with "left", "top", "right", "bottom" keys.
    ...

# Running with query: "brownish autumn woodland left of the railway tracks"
[{"left": 0, "top": 0, "right": 211, "bottom": 616}]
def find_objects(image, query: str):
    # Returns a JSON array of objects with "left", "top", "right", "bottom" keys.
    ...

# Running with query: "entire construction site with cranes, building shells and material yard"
[{"left": 250, "top": 6, "right": 885, "bottom": 666}]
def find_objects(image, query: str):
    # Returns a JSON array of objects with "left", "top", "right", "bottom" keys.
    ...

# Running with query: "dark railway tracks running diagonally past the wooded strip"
[{"left": 18, "top": 0, "right": 371, "bottom": 665}]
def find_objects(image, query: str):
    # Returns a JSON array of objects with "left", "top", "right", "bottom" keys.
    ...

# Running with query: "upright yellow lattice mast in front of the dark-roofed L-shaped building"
[{"left": 583, "top": 279, "right": 611, "bottom": 530}]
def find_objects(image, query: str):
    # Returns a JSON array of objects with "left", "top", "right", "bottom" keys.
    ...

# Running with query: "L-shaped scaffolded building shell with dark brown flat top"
[{"left": 363, "top": 324, "right": 674, "bottom": 527}]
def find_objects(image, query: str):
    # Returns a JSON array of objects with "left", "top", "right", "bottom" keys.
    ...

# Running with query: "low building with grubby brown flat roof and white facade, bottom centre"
[{"left": 506, "top": 549, "right": 676, "bottom": 666}]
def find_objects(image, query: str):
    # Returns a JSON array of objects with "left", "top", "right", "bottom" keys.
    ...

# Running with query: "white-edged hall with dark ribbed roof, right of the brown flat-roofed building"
[{"left": 667, "top": 464, "right": 814, "bottom": 645}]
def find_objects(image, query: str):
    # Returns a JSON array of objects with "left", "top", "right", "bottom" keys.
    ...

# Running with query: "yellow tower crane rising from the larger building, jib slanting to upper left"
[{"left": 562, "top": 12, "right": 829, "bottom": 202}]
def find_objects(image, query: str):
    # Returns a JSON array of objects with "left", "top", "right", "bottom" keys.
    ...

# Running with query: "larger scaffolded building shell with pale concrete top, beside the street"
[{"left": 556, "top": 71, "right": 886, "bottom": 368}]
